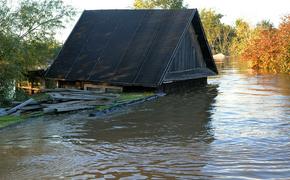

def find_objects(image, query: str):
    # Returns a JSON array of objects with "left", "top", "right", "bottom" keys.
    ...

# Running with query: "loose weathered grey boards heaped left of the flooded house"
[{"left": 0, "top": 88, "right": 155, "bottom": 116}]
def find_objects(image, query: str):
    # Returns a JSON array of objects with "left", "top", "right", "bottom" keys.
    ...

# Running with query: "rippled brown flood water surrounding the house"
[{"left": 0, "top": 61, "right": 290, "bottom": 179}]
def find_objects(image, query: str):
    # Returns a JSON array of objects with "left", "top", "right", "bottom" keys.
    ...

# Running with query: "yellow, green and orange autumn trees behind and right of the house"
[{"left": 134, "top": 0, "right": 290, "bottom": 73}]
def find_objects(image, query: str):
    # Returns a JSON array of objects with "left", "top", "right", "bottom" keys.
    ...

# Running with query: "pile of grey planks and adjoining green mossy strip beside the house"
[{"left": 0, "top": 88, "right": 161, "bottom": 116}]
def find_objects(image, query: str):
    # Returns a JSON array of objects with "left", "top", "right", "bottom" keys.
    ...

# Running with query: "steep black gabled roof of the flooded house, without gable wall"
[{"left": 46, "top": 9, "right": 217, "bottom": 87}]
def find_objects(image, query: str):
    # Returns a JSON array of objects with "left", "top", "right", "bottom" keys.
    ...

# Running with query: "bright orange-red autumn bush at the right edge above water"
[{"left": 241, "top": 15, "right": 290, "bottom": 73}]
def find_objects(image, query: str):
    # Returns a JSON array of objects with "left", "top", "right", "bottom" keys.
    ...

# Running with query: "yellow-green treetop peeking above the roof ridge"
[{"left": 134, "top": 0, "right": 186, "bottom": 9}]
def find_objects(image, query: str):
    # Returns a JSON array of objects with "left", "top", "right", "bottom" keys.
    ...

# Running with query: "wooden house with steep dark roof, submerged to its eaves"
[{"left": 45, "top": 9, "right": 218, "bottom": 92}]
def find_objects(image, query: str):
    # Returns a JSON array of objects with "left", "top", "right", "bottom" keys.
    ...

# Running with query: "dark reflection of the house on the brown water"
[{"left": 79, "top": 85, "right": 217, "bottom": 142}]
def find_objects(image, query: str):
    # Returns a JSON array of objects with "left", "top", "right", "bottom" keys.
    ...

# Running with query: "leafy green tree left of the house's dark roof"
[{"left": 0, "top": 0, "right": 75, "bottom": 104}]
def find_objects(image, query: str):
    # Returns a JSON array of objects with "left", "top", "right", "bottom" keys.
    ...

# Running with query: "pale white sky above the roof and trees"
[{"left": 57, "top": 0, "right": 290, "bottom": 41}]
